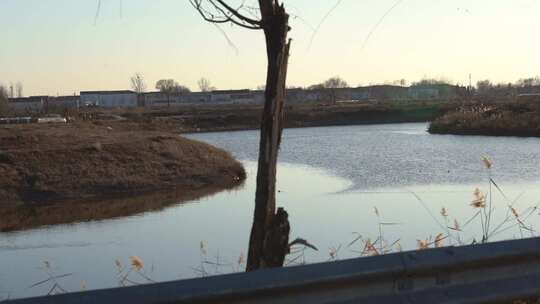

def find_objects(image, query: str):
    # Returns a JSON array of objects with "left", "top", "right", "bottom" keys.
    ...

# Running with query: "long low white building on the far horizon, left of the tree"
[{"left": 80, "top": 90, "right": 138, "bottom": 108}]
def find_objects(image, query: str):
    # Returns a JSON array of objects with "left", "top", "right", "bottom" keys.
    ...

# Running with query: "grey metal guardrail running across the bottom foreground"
[{"left": 7, "top": 238, "right": 540, "bottom": 304}]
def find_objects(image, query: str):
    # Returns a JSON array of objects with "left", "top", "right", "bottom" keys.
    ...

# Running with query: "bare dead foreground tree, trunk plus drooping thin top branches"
[{"left": 190, "top": 0, "right": 290, "bottom": 271}]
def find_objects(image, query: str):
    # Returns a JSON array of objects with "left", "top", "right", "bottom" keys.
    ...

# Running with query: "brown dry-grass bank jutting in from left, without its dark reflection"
[{"left": 0, "top": 123, "right": 245, "bottom": 208}]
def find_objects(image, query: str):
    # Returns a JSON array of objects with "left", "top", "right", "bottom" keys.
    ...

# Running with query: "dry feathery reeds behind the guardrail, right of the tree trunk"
[{"left": 308, "top": 156, "right": 539, "bottom": 264}]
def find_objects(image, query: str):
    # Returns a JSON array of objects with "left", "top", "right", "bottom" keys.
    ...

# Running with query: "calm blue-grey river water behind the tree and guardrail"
[{"left": 0, "top": 124, "right": 540, "bottom": 297}]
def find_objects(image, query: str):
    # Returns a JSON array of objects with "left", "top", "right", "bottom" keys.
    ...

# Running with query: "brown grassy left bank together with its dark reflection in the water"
[{"left": 0, "top": 124, "right": 245, "bottom": 231}]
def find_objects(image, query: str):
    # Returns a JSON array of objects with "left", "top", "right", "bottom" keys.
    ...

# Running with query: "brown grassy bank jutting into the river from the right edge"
[{"left": 428, "top": 103, "right": 540, "bottom": 137}]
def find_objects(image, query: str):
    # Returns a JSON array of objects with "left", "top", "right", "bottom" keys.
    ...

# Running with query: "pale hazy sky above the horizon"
[{"left": 0, "top": 0, "right": 540, "bottom": 95}]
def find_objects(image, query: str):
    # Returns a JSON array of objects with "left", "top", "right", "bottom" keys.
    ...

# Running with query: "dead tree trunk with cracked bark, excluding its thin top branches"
[{"left": 246, "top": 0, "right": 290, "bottom": 271}]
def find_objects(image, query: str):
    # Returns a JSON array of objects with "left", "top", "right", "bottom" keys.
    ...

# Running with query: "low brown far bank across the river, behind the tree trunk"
[{"left": 93, "top": 101, "right": 456, "bottom": 133}]
